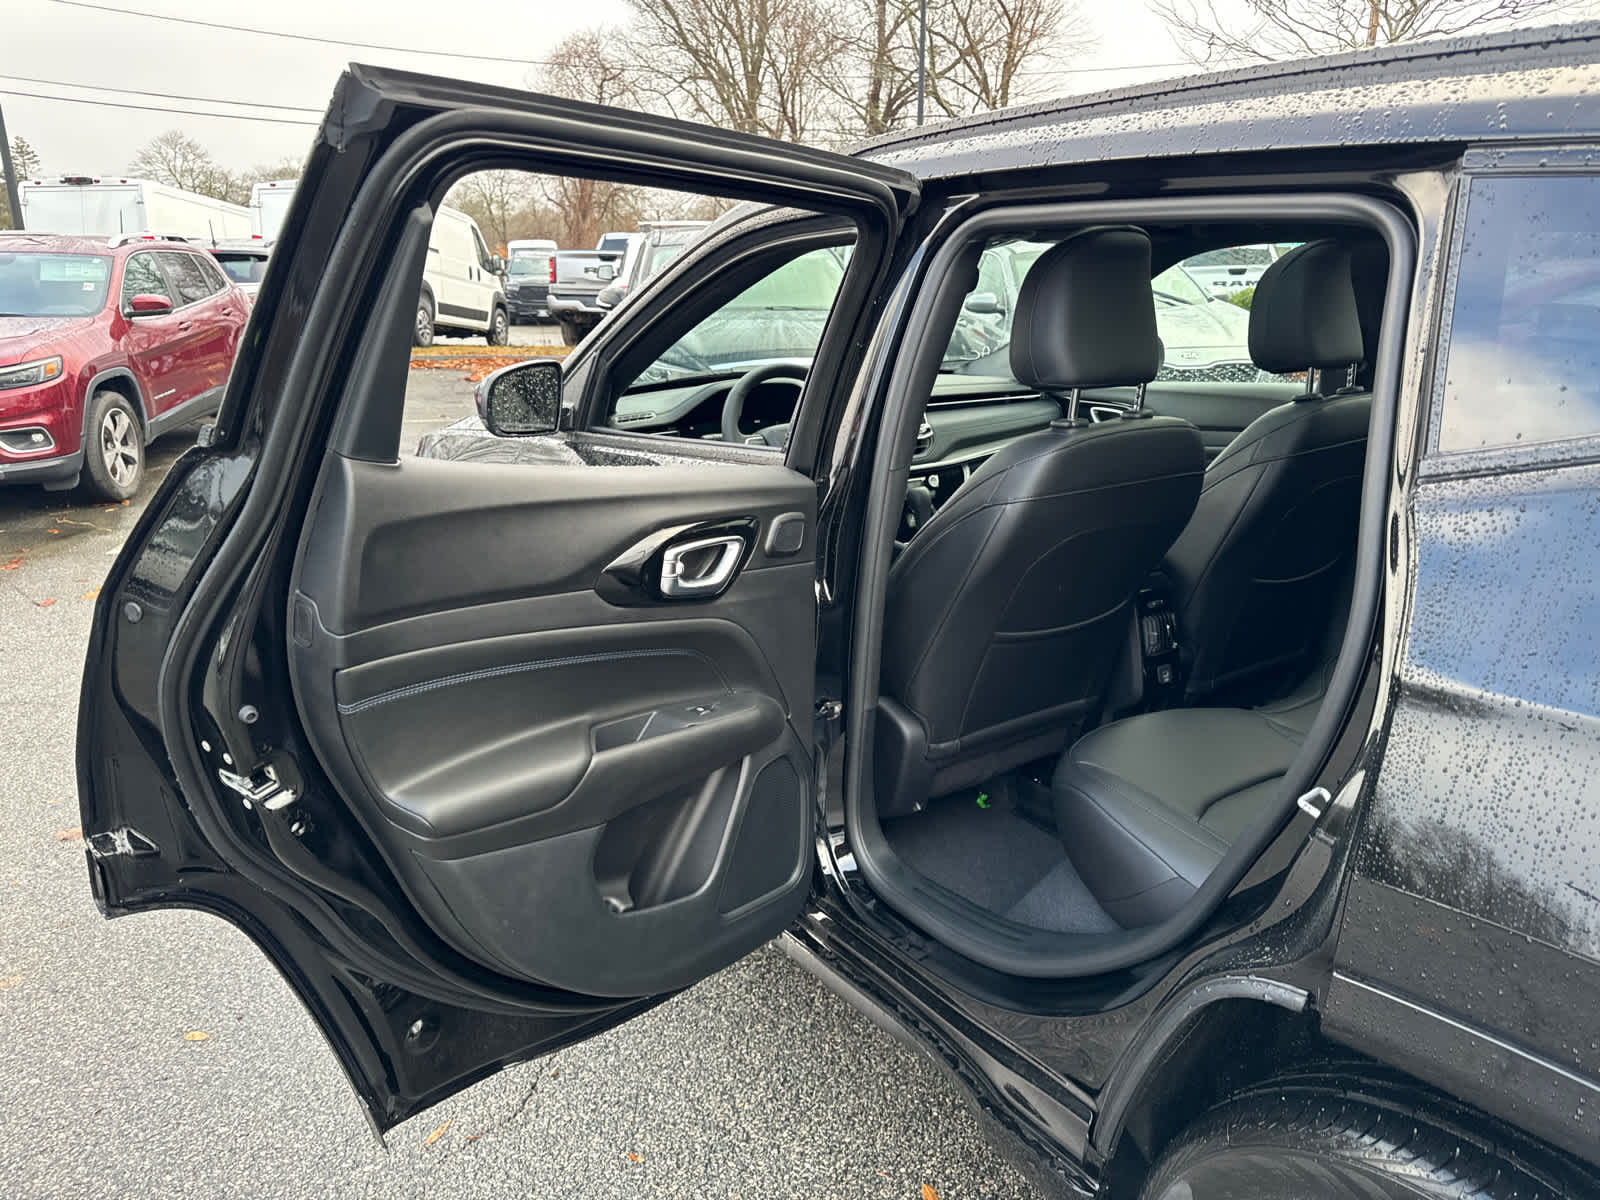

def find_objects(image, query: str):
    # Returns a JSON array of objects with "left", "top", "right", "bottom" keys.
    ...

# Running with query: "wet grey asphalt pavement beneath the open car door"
[{"left": 0, "top": 371, "right": 1027, "bottom": 1200}]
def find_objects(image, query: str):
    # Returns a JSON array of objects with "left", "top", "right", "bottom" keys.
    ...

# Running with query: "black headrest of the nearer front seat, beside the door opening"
[{"left": 1011, "top": 227, "right": 1162, "bottom": 392}]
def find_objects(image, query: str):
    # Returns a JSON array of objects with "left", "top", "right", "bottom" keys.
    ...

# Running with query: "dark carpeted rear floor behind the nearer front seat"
[{"left": 883, "top": 786, "right": 1122, "bottom": 933}]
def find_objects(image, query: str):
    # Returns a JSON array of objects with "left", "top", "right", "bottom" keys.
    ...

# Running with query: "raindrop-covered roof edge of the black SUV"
[{"left": 854, "top": 22, "right": 1600, "bottom": 178}]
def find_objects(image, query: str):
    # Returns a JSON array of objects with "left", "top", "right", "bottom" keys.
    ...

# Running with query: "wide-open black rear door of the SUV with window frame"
[{"left": 78, "top": 69, "right": 917, "bottom": 1128}]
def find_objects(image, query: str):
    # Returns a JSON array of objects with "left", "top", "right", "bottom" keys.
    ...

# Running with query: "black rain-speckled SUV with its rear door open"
[{"left": 78, "top": 26, "right": 1600, "bottom": 1200}]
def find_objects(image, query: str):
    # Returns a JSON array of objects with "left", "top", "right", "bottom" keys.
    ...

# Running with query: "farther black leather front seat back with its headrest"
[{"left": 1166, "top": 240, "right": 1371, "bottom": 704}]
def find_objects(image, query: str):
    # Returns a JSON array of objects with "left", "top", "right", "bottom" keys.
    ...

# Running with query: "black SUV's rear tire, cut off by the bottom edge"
[{"left": 1139, "top": 1086, "right": 1565, "bottom": 1200}]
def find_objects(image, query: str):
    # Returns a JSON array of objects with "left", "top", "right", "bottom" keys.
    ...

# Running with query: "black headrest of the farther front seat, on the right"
[{"left": 1250, "top": 238, "right": 1362, "bottom": 374}]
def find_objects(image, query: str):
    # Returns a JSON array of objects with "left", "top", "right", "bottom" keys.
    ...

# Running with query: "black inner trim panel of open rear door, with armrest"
[{"left": 290, "top": 456, "right": 816, "bottom": 997}]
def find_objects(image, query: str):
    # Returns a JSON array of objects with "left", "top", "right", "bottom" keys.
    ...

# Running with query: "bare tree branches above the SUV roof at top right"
[{"left": 1152, "top": 0, "right": 1582, "bottom": 64}]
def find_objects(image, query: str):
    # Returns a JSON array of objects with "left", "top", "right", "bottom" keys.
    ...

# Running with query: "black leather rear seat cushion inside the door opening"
[{"left": 1051, "top": 709, "right": 1304, "bottom": 926}]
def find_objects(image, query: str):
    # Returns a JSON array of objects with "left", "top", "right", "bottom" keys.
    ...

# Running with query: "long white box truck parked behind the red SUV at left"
[{"left": 18, "top": 174, "right": 250, "bottom": 245}]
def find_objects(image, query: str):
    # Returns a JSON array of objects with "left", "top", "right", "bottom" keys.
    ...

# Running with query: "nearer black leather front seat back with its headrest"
[{"left": 875, "top": 229, "right": 1205, "bottom": 816}]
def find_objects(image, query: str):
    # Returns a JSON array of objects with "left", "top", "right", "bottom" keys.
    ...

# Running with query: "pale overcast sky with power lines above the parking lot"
[{"left": 9, "top": 0, "right": 1184, "bottom": 174}]
